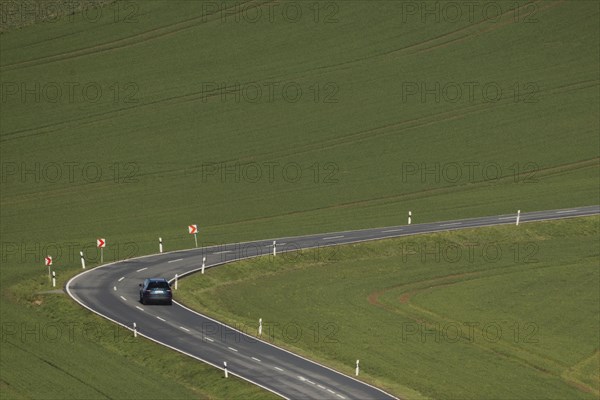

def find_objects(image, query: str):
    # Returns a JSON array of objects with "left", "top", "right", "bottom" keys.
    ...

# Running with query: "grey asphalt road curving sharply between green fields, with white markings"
[{"left": 66, "top": 206, "right": 600, "bottom": 400}]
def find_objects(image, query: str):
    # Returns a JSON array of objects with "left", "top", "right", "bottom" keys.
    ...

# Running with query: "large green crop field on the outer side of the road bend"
[{"left": 0, "top": 0, "right": 600, "bottom": 399}]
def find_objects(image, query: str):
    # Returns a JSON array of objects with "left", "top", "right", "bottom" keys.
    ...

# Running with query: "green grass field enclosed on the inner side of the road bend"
[{"left": 176, "top": 217, "right": 600, "bottom": 399}]
